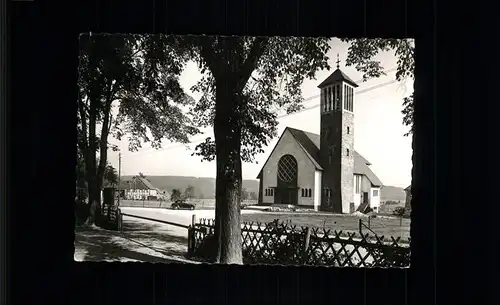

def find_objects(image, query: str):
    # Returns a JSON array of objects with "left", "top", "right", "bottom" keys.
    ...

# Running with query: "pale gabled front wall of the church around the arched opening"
[{"left": 260, "top": 130, "right": 315, "bottom": 206}]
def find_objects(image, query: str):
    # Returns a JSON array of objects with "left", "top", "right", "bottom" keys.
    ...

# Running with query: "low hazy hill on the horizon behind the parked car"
[{"left": 121, "top": 175, "right": 259, "bottom": 199}]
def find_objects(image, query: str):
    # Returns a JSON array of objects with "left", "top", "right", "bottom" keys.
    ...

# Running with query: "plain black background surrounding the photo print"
[{"left": 2, "top": 0, "right": 498, "bottom": 305}]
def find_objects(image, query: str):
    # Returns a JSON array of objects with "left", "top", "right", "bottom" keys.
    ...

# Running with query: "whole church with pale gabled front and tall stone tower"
[{"left": 257, "top": 60, "right": 382, "bottom": 213}]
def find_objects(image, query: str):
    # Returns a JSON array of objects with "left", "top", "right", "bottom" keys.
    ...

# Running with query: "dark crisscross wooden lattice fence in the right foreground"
[{"left": 188, "top": 219, "right": 410, "bottom": 267}]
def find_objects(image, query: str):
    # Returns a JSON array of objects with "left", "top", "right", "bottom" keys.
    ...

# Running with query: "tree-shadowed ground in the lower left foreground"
[{"left": 75, "top": 220, "right": 195, "bottom": 263}]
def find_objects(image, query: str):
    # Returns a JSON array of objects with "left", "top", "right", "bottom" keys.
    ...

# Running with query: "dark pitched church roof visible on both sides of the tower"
[{"left": 257, "top": 127, "right": 383, "bottom": 186}]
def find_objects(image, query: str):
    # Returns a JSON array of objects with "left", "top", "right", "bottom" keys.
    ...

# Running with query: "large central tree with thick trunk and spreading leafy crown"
[{"left": 90, "top": 35, "right": 330, "bottom": 264}]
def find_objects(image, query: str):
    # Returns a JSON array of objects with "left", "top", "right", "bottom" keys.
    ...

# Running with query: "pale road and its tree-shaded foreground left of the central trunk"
[{"left": 74, "top": 207, "right": 258, "bottom": 263}]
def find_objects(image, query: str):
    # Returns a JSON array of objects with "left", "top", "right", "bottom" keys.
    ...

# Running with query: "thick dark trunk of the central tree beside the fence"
[{"left": 214, "top": 81, "right": 243, "bottom": 264}]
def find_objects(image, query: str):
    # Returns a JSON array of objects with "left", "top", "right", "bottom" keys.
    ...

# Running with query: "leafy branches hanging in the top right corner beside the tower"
[{"left": 342, "top": 38, "right": 415, "bottom": 136}]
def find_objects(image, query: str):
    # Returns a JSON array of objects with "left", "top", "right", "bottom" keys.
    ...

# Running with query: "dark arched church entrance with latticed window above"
[{"left": 274, "top": 155, "right": 299, "bottom": 205}]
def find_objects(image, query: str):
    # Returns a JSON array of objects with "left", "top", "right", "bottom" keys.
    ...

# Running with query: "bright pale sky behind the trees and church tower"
[{"left": 108, "top": 38, "right": 413, "bottom": 187}]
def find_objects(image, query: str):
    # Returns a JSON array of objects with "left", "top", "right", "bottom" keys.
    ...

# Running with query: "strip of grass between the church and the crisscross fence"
[{"left": 242, "top": 212, "right": 410, "bottom": 240}]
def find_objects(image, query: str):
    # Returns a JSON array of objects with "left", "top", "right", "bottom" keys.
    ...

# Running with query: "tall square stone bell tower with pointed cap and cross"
[{"left": 318, "top": 54, "right": 358, "bottom": 213}]
